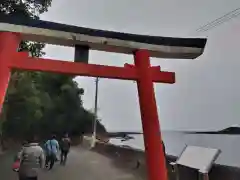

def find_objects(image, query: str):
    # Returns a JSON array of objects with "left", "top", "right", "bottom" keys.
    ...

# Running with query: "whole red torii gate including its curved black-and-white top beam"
[{"left": 0, "top": 15, "right": 206, "bottom": 180}]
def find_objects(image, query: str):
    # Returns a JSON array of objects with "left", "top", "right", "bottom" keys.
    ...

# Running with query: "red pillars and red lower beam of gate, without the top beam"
[{"left": 0, "top": 33, "right": 175, "bottom": 180}]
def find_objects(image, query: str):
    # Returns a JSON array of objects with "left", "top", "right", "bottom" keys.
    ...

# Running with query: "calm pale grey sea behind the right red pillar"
[{"left": 110, "top": 131, "right": 240, "bottom": 167}]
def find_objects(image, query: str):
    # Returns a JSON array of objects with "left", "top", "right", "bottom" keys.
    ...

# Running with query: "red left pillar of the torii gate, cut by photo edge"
[{"left": 0, "top": 32, "right": 20, "bottom": 113}]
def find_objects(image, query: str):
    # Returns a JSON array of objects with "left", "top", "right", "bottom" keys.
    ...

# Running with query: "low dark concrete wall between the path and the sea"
[{"left": 92, "top": 142, "right": 240, "bottom": 180}]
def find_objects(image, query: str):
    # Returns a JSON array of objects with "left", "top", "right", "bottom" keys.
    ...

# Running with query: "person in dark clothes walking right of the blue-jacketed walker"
[{"left": 60, "top": 134, "right": 71, "bottom": 165}]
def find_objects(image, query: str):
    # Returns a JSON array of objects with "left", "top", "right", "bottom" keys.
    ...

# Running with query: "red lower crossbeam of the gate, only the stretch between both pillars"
[{"left": 11, "top": 55, "right": 137, "bottom": 79}]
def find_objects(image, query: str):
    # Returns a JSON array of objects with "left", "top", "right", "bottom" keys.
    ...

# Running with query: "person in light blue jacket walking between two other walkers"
[{"left": 45, "top": 135, "right": 59, "bottom": 170}]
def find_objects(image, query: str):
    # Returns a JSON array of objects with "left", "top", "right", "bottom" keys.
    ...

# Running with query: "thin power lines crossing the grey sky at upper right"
[{"left": 195, "top": 8, "right": 240, "bottom": 33}]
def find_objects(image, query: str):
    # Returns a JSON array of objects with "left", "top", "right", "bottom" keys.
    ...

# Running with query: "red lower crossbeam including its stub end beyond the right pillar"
[{"left": 10, "top": 52, "right": 175, "bottom": 84}]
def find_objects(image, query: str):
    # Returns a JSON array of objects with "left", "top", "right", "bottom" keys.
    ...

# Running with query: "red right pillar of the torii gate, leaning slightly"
[{"left": 134, "top": 50, "right": 167, "bottom": 180}]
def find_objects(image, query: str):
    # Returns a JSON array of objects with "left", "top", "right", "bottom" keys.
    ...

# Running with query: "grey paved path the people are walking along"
[{"left": 0, "top": 147, "right": 140, "bottom": 180}]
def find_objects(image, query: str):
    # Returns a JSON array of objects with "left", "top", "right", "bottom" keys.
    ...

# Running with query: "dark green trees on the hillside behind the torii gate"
[{"left": 0, "top": 0, "right": 105, "bottom": 139}]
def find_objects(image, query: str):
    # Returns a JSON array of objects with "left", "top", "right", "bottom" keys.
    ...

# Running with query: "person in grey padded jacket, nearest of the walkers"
[{"left": 18, "top": 138, "right": 45, "bottom": 180}]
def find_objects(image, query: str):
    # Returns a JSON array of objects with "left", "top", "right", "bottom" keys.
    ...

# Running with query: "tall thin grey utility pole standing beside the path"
[{"left": 91, "top": 77, "right": 99, "bottom": 148}]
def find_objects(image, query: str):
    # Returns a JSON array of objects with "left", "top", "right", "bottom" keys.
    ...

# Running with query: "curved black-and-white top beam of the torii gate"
[{"left": 0, "top": 16, "right": 206, "bottom": 59}]
